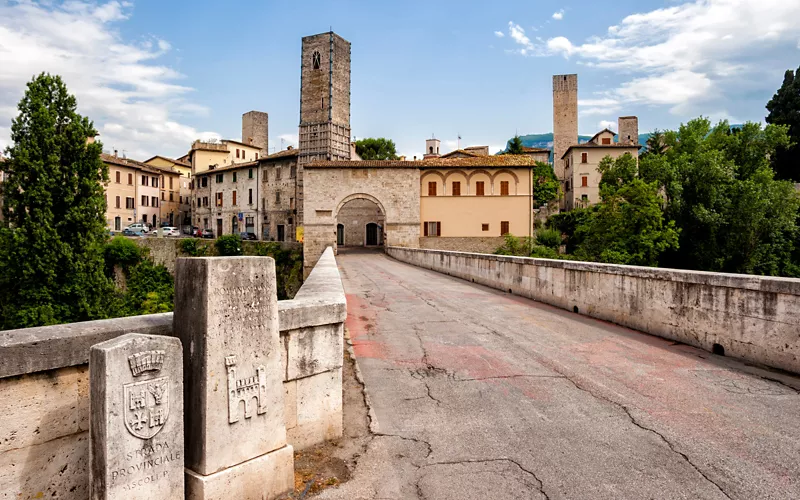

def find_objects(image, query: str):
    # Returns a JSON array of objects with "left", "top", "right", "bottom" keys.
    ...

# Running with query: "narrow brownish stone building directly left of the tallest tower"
[{"left": 258, "top": 146, "right": 301, "bottom": 241}]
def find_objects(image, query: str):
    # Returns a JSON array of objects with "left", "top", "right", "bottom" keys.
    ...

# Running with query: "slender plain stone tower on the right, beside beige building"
[{"left": 553, "top": 75, "right": 578, "bottom": 205}]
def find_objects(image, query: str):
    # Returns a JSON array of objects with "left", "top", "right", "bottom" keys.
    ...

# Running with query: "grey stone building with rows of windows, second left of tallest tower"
[{"left": 192, "top": 161, "right": 261, "bottom": 238}]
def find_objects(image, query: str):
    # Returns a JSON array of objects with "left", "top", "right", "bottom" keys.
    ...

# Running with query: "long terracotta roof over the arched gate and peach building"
[{"left": 305, "top": 155, "right": 536, "bottom": 169}]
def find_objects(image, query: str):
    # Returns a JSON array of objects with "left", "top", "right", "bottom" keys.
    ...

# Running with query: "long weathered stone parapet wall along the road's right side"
[{"left": 387, "top": 248, "right": 800, "bottom": 373}]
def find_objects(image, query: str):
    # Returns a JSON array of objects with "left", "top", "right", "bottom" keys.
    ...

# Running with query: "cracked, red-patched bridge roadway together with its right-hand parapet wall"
[{"left": 321, "top": 248, "right": 800, "bottom": 499}]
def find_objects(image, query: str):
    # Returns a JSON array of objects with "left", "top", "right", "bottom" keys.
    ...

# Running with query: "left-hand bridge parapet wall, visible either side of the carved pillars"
[{"left": 0, "top": 250, "right": 347, "bottom": 500}]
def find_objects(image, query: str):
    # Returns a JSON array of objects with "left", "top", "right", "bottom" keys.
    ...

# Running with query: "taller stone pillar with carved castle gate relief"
[{"left": 173, "top": 257, "right": 294, "bottom": 500}]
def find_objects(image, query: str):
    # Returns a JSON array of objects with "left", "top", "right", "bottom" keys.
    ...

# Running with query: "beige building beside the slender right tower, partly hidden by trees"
[{"left": 561, "top": 122, "right": 640, "bottom": 210}]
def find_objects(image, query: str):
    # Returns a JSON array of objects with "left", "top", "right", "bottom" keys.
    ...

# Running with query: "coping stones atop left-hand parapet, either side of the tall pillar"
[{"left": 0, "top": 247, "right": 347, "bottom": 378}]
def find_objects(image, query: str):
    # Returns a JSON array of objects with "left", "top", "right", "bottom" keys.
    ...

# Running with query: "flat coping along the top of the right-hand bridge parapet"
[{"left": 388, "top": 247, "right": 800, "bottom": 295}]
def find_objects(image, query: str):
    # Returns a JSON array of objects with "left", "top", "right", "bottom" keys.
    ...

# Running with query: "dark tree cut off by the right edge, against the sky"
[{"left": 767, "top": 68, "right": 800, "bottom": 182}]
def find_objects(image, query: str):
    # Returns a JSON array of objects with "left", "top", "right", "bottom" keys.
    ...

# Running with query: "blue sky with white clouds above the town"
[{"left": 0, "top": 0, "right": 800, "bottom": 160}]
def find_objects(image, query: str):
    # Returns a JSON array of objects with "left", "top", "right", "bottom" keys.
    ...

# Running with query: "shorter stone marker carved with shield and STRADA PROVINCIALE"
[{"left": 89, "top": 333, "right": 184, "bottom": 500}]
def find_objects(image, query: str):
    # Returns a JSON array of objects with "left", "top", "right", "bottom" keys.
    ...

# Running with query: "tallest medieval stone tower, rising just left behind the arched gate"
[{"left": 297, "top": 31, "right": 350, "bottom": 225}]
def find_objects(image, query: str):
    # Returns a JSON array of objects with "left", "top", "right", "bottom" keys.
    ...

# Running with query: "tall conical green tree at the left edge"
[{"left": 0, "top": 74, "right": 113, "bottom": 328}]
